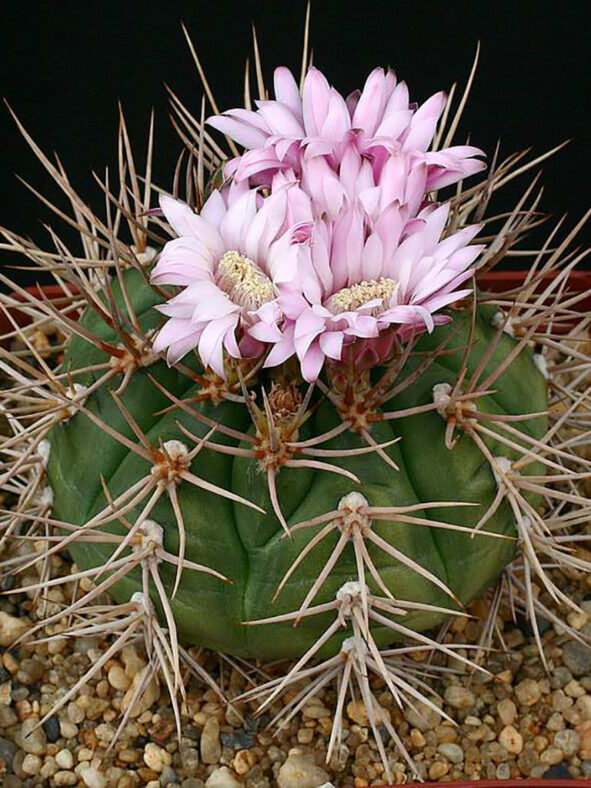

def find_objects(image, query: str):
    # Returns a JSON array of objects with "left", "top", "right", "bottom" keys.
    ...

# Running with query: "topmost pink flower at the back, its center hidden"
[{"left": 208, "top": 66, "right": 485, "bottom": 191}]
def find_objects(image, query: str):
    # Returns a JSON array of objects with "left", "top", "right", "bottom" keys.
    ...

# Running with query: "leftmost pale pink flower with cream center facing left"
[{"left": 151, "top": 185, "right": 300, "bottom": 377}]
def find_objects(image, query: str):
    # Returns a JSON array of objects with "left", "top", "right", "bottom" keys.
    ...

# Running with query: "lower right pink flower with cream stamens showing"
[{"left": 265, "top": 200, "right": 483, "bottom": 382}]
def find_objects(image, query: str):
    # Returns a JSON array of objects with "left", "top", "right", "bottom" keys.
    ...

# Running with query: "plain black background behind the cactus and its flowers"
[{"left": 0, "top": 0, "right": 591, "bottom": 286}]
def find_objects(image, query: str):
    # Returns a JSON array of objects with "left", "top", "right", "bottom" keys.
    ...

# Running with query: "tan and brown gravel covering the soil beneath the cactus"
[{"left": 0, "top": 540, "right": 591, "bottom": 788}]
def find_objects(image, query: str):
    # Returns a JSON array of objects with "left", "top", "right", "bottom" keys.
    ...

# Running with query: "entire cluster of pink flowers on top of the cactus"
[{"left": 152, "top": 68, "right": 484, "bottom": 382}]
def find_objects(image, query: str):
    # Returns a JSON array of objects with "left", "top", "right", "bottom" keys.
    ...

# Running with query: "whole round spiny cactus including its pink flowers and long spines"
[{"left": 0, "top": 20, "right": 591, "bottom": 779}]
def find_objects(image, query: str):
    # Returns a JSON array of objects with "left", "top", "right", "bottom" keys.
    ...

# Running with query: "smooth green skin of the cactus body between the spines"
[{"left": 48, "top": 271, "right": 547, "bottom": 659}]
